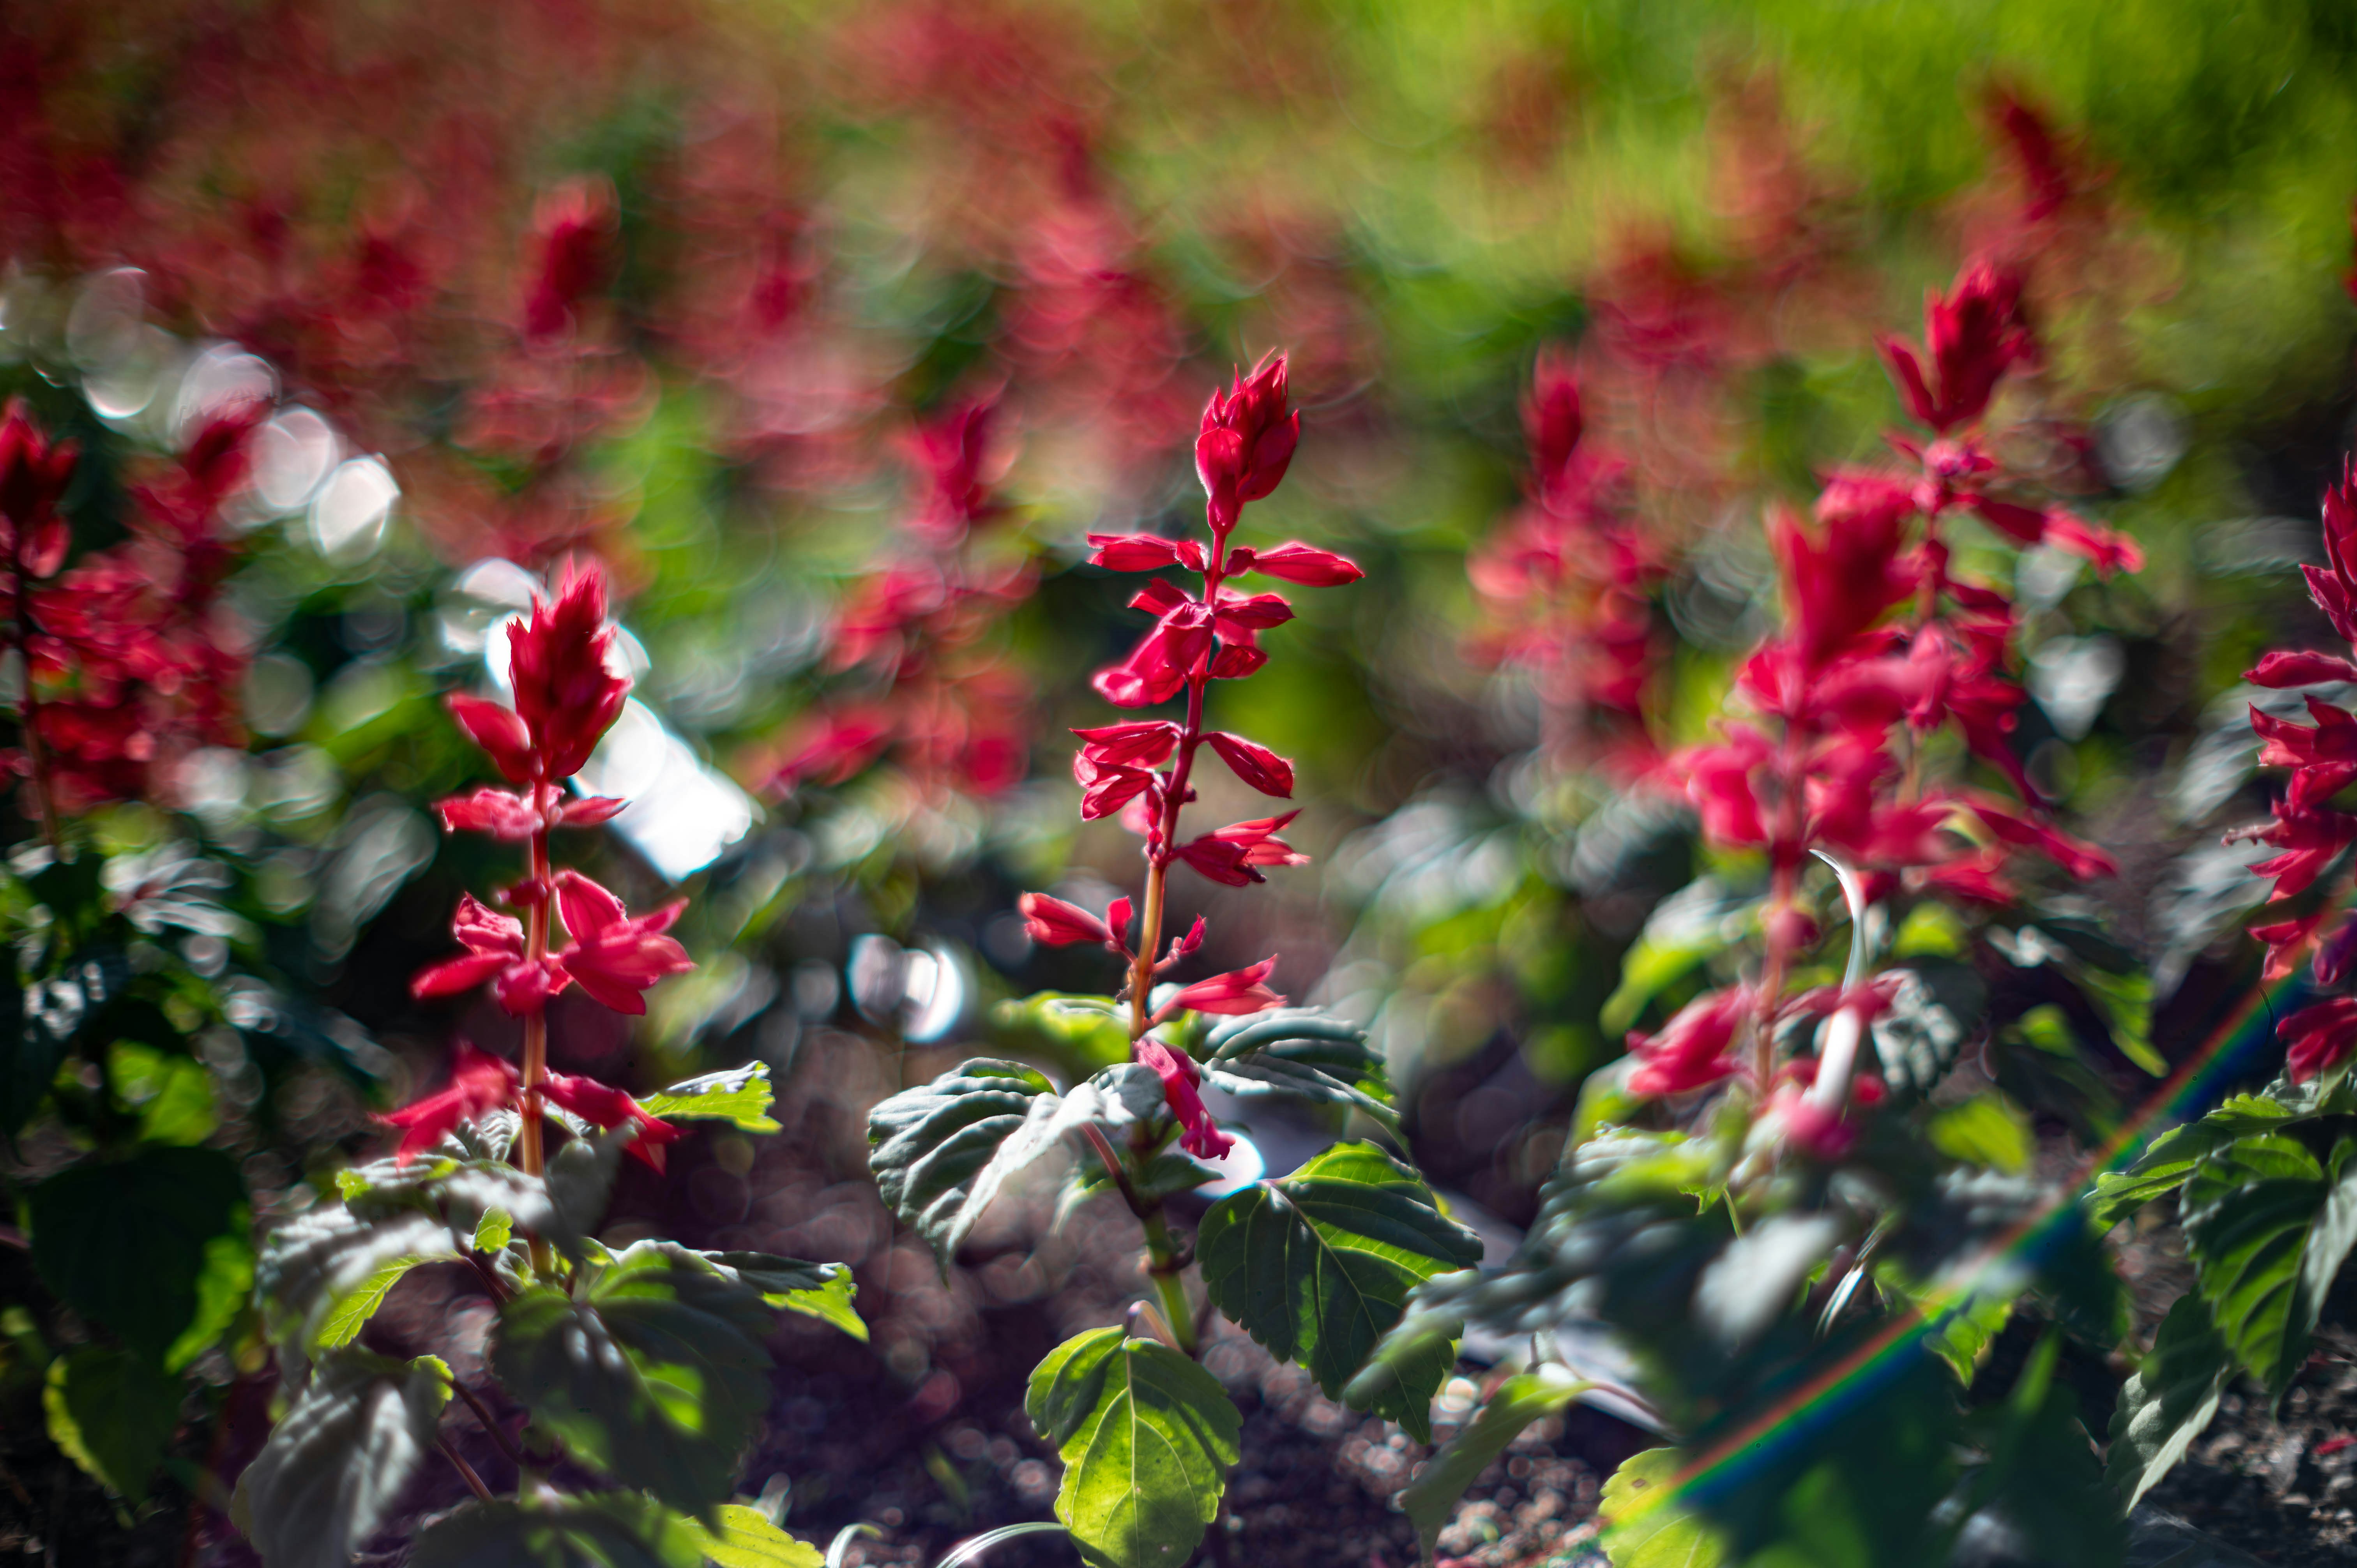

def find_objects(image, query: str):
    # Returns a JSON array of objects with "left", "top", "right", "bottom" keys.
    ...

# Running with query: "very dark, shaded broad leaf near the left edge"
[{"left": 26, "top": 1148, "right": 245, "bottom": 1358}]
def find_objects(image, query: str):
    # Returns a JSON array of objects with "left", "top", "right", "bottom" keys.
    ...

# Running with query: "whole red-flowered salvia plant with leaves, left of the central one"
[{"left": 236, "top": 568, "right": 865, "bottom": 1568}]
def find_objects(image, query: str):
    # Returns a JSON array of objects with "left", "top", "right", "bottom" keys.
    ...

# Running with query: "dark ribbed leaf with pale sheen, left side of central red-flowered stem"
[{"left": 868, "top": 1059, "right": 1063, "bottom": 1264}]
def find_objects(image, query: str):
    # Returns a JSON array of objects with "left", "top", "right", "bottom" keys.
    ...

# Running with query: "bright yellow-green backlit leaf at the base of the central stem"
[{"left": 1023, "top": 1328, "right": 1244, "bottom": 1568}]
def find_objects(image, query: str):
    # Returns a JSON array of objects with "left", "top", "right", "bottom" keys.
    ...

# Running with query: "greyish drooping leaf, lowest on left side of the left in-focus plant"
[{"left": 231, "top": 1351, "right": 450, "bottom": 1568}]
